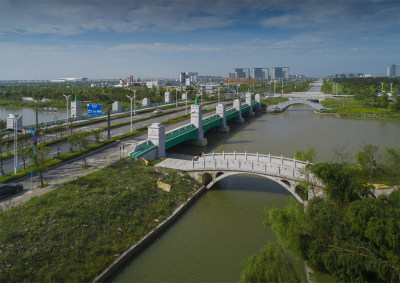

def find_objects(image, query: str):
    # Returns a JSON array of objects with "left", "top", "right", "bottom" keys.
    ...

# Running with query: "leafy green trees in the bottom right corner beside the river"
[{"left": 242, "top": 145, "right": 400, "bottom": 282}]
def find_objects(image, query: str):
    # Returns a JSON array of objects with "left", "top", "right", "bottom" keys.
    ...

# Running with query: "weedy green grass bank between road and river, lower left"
[{"left": 0, "top": 161, "right": 199, "bottom": 282}]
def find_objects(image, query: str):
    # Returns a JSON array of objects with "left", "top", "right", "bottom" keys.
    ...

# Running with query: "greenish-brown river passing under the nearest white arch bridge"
[{"left": 113, "top": 106, "right": 400, "bottom": 282}]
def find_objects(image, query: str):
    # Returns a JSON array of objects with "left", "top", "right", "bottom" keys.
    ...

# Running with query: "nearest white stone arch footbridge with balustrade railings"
[{"left": 156, "top": 152, "right": 322, "bottom": 203}]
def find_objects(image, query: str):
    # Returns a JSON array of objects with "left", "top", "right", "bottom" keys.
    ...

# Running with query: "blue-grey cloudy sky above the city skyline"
[{"left": 0, "top": 0, "right": 400, "bottom": 80}]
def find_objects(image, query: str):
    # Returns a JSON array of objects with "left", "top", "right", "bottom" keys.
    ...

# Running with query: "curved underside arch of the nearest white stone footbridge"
[{"left": 202, "top": 171, "right": 304, "bottom": 203}]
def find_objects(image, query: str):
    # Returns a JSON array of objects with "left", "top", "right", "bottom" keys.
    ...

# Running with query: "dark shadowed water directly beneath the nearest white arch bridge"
[{"left": 211, "top": 174, "right": 291, "bottom": 196}]
